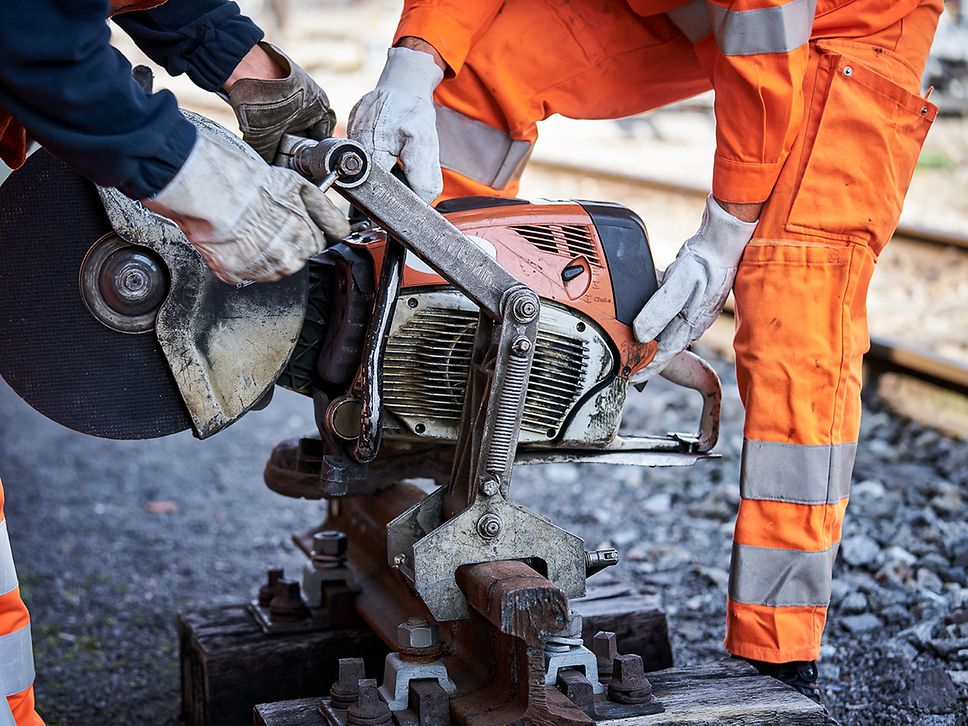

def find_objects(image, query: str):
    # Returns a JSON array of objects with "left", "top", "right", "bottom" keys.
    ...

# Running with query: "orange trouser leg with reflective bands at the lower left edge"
[{"left": 0, "top": 483, "right": 44, "bottom": 726}]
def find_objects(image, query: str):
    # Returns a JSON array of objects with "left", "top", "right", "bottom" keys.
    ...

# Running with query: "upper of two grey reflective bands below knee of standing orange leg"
[{"left": 739, "top": 439, "right": 857, "bottom": 504}]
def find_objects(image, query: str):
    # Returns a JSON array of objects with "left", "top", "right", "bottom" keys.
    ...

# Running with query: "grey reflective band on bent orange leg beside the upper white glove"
[{"left": 435, "top": 104, "right": 534, "bottom": 189}]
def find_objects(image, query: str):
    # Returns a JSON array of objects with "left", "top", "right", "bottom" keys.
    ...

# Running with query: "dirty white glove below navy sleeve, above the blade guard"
[{"left": 144, "top": 129, "right": 350, "bottom": 285}]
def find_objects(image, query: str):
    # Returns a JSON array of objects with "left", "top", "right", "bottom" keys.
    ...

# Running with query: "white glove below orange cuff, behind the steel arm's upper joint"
[{"left": 346, "top": 48, "right": 444, "bottom": 202}]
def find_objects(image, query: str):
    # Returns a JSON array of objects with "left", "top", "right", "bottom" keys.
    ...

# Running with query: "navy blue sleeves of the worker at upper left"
[{"left": 0, "top": 0, "right": 262, "bottom": 199}]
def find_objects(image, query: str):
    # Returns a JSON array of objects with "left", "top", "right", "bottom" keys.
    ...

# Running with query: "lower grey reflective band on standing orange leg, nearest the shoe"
[{"left": 729, "top": 544, "right": 840, "bottom": 607}]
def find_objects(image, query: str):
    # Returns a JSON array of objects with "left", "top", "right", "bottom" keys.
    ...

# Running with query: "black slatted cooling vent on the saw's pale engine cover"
[{"left": 383, "top": 306, "right": 588, "bottom": 438}]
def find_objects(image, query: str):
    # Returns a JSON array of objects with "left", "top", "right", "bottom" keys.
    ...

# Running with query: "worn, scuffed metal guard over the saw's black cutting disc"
[{"left": 98, "top": 112, "right": 309, "bottom": 438}]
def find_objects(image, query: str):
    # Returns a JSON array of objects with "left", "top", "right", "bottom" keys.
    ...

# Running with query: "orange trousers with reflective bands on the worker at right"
[{"left": 435, "top": 0, "right": 942, "bottom": 663}]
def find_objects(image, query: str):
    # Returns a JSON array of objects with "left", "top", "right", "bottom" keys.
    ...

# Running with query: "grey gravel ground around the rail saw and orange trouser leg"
[{"left": 0, "top": 350, "right": 968, "bottom": 726}]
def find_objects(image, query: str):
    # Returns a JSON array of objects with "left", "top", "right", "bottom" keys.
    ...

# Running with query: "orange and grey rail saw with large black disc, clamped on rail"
[{"left": 0, "top": 112, "right": 721, "bottom": 723}]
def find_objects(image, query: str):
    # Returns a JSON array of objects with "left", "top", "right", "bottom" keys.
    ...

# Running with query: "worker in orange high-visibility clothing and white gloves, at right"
[{"left": 349, "top": 0, "right": 943, "bottom": 712}]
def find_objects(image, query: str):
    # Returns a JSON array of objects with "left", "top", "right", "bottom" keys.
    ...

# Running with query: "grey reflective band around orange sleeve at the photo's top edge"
[{"left": 707, "top": 0, "right": 817, "bottom": 55}]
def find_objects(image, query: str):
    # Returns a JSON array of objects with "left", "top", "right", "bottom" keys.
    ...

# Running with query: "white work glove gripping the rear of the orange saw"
[{"left": 631, "top": 196, "right": 756, "bottom": 383}]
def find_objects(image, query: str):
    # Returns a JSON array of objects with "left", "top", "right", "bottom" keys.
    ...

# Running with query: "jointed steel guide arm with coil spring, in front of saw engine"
[{"left": 276, "top": 136, "right": 541, "bottom": 517}]
